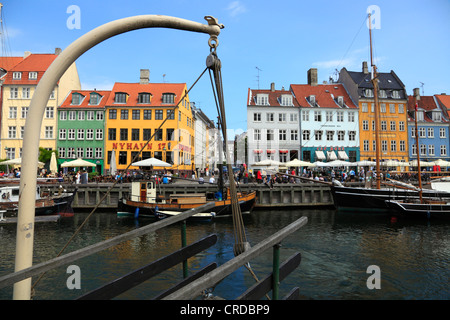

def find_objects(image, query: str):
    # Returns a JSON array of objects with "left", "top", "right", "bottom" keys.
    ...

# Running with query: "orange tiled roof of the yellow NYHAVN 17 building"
[{"left": 106, "top": 82, "right": 187, "bottom": 106}]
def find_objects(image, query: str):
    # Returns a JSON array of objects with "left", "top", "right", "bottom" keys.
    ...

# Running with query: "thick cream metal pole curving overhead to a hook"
[{"left": 13, "top": 15, "right": 223, "bottom": 300}]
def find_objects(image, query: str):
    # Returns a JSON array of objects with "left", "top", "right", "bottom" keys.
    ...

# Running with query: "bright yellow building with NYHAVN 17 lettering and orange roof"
[{"left": 105, "top": 70, "right": 195, "bottom": 173}]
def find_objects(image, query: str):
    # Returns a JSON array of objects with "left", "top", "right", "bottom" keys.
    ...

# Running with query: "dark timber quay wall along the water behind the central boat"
[{"left": 45, "top": 183, "right": 333, "bottom": 209}]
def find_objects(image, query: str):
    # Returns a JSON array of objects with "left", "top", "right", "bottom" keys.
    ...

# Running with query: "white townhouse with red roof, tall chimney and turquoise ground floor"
[{"left": 291, "top": 68, "right": 360, "bottom": 162}]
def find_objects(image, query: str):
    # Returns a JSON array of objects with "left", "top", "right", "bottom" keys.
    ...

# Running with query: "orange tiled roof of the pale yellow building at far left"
[{"left": 4, "top": 53, "right": 58, "bottom": 85}]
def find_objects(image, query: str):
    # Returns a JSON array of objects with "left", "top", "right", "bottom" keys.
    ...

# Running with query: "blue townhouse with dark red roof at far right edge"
[{"left": 408, "top": 88, "right": 450, "bottom": 162}]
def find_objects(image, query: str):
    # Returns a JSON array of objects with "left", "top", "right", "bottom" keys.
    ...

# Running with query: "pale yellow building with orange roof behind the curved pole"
[{"left": 0, "top": 49, "right": 81, "bottom": 159}]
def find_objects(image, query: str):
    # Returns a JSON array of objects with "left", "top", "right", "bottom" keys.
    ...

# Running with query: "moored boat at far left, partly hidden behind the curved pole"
[{"left": 0, "top": 183, "right": 77, "bottom": 217}]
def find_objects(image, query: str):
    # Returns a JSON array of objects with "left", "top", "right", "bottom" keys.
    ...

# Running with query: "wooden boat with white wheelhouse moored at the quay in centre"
[{"left": 117, "top": 181, "right": 256, "bottom": 219}]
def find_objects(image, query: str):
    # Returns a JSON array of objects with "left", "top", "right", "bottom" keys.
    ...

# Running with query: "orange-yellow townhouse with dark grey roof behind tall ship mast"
[{"left": 339, "top": 62, "right": 409, "bottom": 166}]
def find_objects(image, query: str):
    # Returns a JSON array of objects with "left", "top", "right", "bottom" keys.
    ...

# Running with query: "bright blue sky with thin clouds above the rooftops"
[{"left": 0, "top": 0, "right": 450, "bottom": 138}]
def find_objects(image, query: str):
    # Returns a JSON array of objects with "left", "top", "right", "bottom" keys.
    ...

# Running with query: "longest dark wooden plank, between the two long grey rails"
[{"left": 77, "top": 234, "right": 217, "bottom": 300}]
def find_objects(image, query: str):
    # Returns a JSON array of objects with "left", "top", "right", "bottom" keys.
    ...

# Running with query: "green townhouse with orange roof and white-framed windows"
[{"left": 56, "top": 90, "right": 110, "bottom": 173}]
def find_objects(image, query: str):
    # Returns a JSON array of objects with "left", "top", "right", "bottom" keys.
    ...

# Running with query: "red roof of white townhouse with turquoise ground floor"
[{"left": 291, "top": 83, "right": 357, "bottom": 109}]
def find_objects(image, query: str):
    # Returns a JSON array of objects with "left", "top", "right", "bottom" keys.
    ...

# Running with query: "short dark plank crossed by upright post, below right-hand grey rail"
[{"left": 236, "top": 253, "right": 302, "bottom": 300}]
